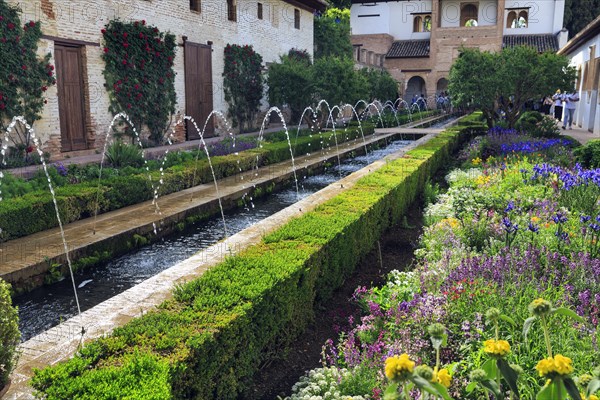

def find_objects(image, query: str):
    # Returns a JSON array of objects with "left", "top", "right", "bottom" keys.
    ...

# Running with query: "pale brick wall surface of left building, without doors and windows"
[{"left": 8, "top": 0, "right": 313, "bottom": 160}]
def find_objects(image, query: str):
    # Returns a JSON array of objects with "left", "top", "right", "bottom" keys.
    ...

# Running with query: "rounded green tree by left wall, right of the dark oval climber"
[{"left": 267, "top": 49, "right": 315, "bottom": 121}]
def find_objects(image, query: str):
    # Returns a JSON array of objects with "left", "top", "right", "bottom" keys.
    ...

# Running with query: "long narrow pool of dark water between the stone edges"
[{"left": 14, "top": 140, "right": 411, "bottom": 341}]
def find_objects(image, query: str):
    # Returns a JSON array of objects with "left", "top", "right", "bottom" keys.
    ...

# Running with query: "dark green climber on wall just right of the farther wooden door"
[{"left": 223, "top": 43, "right": 264, "bottom": 132}]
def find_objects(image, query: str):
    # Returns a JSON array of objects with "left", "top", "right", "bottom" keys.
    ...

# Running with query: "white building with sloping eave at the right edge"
[{"left": 558, "top": 16, "right": 600, "bottom": 136}]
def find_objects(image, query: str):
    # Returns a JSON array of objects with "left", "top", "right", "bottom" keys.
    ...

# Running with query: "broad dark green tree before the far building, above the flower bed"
[{"left": 448, "top": 46, "right": 575, "bottom": 127}]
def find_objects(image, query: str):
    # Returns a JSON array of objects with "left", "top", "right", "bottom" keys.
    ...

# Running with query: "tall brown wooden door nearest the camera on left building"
[{"left": 54, "top": 44, "right": 87, "bottom": 151}]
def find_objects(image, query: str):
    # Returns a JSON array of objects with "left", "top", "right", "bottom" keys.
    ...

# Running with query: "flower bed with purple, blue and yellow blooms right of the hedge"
[{"left": 291, "top": 126, "right": 600, "bottom": 400}]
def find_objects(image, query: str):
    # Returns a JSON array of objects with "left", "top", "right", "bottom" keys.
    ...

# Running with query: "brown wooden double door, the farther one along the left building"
[{"left": 184, "top": 41, "right": 215, "bottom": 140}]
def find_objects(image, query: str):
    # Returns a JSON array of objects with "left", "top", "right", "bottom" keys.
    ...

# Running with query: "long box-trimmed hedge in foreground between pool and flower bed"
[{"left": 32, "top": 113, "right": 486, "bottom": 400}]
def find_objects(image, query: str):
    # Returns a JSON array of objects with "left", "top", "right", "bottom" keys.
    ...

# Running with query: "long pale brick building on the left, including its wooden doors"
[{"left": 8, "top": 0, "right": 325, "bottom": 160}]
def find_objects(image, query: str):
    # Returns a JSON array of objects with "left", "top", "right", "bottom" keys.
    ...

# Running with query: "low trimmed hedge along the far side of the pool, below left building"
[{"left": 0, "top": 125, "right": 374, "bottom": 243}]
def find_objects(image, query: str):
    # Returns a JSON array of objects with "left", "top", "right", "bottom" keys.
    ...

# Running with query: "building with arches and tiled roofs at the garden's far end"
[{"left": 350, "top": 0, "right": 567, "bottom": 101}]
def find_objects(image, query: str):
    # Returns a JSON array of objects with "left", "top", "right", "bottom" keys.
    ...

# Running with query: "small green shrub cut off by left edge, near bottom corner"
[{"left": 0, "top": 279, "right": 21, "bottom": 389}]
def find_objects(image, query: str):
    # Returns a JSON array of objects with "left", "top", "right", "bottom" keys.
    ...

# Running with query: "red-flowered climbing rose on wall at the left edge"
[{"left": 0, "top": 0, "right": 56, "bottom": 155}]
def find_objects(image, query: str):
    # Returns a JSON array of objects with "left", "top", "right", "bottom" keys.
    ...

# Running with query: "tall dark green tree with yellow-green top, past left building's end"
[{"left": 314, "top": 8, "right": 352, "bottom": 60}]
